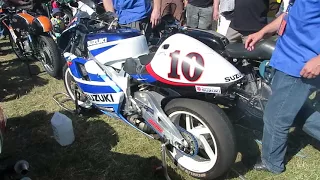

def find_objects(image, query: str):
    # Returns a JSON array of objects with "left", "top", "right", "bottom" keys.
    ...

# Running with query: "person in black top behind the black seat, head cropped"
[{"left": 226, "top": 0, "right": 269, "bottom": 43}]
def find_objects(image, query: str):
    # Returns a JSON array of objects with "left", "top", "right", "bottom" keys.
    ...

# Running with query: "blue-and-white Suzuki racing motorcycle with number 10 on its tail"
[{"left": 58, "top": 8, "right": 238, "bottom": 179}]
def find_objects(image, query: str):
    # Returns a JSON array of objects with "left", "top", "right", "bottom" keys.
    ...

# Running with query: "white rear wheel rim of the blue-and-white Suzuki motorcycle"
[{"left": 169, "top": 111, "right": 218, "bottom": 173}]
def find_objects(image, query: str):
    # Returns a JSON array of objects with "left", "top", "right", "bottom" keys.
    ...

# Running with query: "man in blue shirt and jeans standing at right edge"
[{"left": 245, "top": 0, "right": 320, "bottom": 174}]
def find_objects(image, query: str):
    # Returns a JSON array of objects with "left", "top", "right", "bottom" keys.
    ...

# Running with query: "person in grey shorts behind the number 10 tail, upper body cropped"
[{"left": 185, "top": 0, "right": 216, "bottom": 30}]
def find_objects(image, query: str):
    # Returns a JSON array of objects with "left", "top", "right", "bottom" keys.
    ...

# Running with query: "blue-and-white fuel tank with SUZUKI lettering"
[{"left": 85, "top": 28, "right": 149, "bottom": 69}]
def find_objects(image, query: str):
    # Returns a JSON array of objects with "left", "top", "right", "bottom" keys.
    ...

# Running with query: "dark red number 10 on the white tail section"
[{"left": 168, "top": 51, "right": 204, "bottom": 82}]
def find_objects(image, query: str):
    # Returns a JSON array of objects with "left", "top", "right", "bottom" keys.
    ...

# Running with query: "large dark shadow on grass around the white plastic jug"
[{"left": 1, "top": 111, "right": 184, "bottom": 180}]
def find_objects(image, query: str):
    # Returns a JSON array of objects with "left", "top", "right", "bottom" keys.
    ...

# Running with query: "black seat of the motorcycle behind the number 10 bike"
[{"left": 226, "top": 38, "right": 276, "bottom": 60}]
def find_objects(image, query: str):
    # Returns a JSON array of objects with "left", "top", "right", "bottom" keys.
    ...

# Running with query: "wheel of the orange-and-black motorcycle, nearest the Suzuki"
[{"left": 38, "top": 36, "right": 61, "bottom": 77}]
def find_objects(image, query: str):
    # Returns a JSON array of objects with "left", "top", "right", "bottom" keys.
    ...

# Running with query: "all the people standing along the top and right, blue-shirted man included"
[{"left": 0, "top": 0, "right": 320, "bottom": 174}]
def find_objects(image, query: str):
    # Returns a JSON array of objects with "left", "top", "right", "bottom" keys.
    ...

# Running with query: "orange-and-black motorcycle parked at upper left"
[{"left": 0, "top": 4, "right": 62, "bottom": 77}]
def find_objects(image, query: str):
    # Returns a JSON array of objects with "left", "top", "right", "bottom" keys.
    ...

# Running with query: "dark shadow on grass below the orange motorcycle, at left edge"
[{"left": 0, "top": 59, "right": 48, "bottom": 102}]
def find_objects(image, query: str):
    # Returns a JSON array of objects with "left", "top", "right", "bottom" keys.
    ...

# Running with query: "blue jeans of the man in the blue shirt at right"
[{"left": 261, "top": 71, "right": 320, "bottom": 174}]
